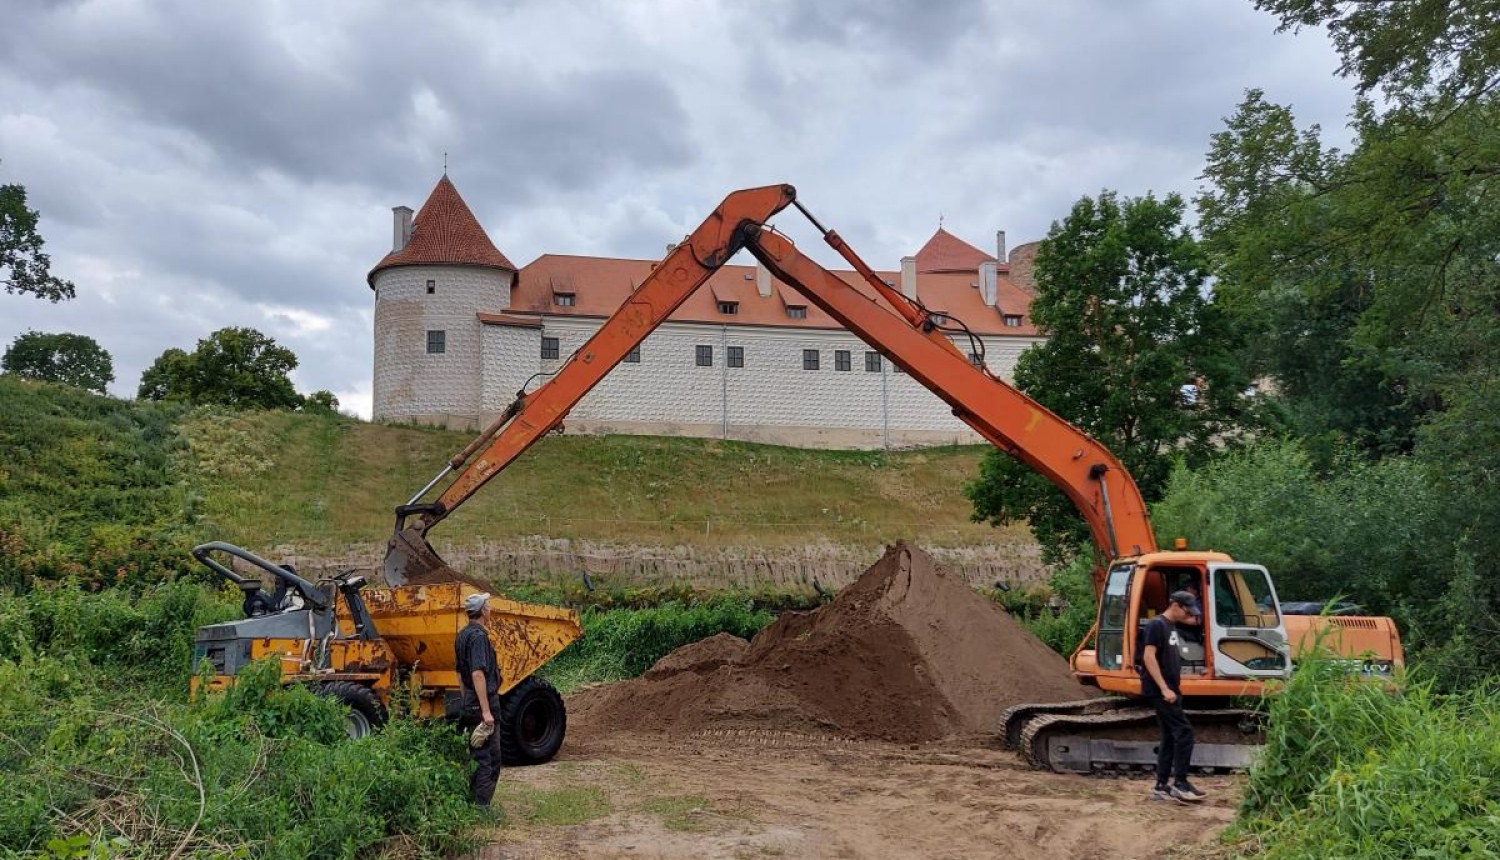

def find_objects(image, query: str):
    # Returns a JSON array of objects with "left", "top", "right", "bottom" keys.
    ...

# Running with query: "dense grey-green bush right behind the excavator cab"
[{"left": 1152, "top": 441, "right": 1500, "bottom": 689}]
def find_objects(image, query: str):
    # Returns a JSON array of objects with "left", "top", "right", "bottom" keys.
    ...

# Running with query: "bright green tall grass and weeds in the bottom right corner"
[{"left": 1239, "top": 659, "right": 1500, "bottom": 860}]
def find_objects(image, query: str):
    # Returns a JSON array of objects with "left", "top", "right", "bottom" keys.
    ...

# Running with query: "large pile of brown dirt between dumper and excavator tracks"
[{"left": 570, "top": 542, "right": 1088, "bottom": 741}]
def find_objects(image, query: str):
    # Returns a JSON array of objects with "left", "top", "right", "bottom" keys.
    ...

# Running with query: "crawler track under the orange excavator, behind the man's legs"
[{"left": 1007, "top": 699, "right": 1260, "bottom": 774}]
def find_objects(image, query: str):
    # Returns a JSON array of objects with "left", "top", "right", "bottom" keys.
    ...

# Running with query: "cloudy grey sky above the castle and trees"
[{"left": 0, "top": 0, "right": 1350, "bottom": 414}]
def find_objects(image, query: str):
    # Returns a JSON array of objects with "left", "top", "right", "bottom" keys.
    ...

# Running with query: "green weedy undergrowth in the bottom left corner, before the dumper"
[{"left": 0, "top": 656, "right": 477, "bottom": 860}]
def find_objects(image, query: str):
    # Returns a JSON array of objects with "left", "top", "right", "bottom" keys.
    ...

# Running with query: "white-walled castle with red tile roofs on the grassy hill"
[{"left": 368, "top": 174, "right": 1041, "bottom": 447}]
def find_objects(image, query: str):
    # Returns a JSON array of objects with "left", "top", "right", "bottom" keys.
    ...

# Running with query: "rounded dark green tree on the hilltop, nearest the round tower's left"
[{"left": 138, "top": 329, "right": 303, "bottom": 410}]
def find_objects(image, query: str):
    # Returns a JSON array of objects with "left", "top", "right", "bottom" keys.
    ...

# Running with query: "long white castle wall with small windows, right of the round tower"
[{"left": 482, "top": 317, "right": 1041, "bottom": 447}]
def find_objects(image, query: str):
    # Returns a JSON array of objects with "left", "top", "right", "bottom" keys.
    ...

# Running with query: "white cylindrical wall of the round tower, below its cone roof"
[{"left": 372, "top": 266, "right": 515, "bottom": 426}]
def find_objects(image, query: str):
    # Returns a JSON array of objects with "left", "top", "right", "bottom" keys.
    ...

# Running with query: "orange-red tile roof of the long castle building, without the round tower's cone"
[{"left": 506, "top": 247, "right": 1037, "bottom": 336}]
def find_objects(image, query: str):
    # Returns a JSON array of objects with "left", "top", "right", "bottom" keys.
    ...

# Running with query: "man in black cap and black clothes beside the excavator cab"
[{"left": 1136, "top": 591, "right": 1208, "bottom": 803}]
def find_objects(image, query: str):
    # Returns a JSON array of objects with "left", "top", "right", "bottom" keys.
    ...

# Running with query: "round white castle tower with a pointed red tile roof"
[{"left": 368, "top": 174, "right": 516, "bottom": 428}]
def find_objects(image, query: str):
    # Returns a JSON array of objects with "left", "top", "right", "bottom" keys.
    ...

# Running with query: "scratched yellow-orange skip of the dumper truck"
[{"left": 363, "top": 581, "right": 584, "bottom": 693}]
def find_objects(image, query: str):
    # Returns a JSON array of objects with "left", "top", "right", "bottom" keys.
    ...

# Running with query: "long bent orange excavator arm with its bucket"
[{"left": 386, "top": 185, "right": 1157, "bottom": 590}]
